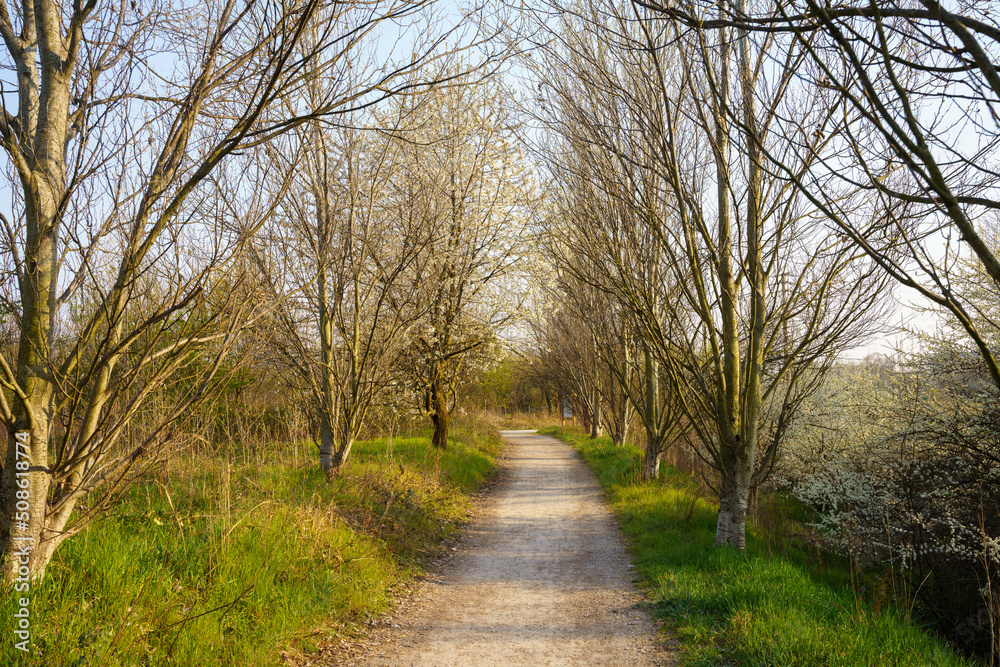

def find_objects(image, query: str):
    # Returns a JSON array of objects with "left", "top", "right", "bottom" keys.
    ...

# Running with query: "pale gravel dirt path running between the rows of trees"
[{"left": 338, "top": 431, "right": 672, "bottom": 667}]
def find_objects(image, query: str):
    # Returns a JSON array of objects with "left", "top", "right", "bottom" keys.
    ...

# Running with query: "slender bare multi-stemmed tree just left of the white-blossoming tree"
[{"left": 257, "top": 114, "right": 435, "bottom": 475}]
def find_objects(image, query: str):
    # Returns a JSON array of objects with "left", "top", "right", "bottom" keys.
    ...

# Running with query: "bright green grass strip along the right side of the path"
[{"left": 542, "top": 428, "right": 970, "bottom": 666}]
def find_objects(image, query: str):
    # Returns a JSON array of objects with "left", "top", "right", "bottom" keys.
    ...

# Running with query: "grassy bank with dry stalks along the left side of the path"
[{"left": 0, "top": 425, "right": 502, "bottom": 667}]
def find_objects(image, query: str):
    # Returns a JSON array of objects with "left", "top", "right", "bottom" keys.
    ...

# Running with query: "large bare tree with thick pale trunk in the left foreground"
[{"left": 0, "top": 0, "right": 486, "bottom": 579}]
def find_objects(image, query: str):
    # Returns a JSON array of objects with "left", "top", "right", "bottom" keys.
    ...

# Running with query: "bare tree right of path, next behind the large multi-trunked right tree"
[{"left": 547, "top": 118, "right": 690, "bottom": 480}]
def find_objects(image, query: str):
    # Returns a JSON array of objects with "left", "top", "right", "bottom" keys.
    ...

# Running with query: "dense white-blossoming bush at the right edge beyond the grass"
[{"left": 777, "top": 358, "right": 1000, "bottom": 657}]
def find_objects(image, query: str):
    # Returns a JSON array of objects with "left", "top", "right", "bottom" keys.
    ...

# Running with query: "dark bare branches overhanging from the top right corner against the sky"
[{"left": 642, "top": 0, "right": 1000, "bottom": 387}]
